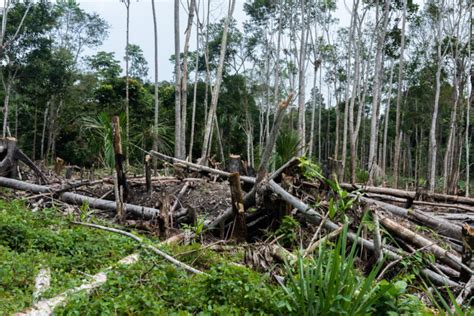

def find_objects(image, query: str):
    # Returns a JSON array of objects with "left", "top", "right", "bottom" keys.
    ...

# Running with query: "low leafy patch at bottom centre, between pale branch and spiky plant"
[{"left": 57, "top": 254, "right": 284, "bottom": 315}]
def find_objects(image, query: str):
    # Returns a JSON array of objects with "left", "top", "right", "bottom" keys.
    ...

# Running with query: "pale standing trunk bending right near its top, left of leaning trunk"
[{"left": 180, "top": 0, "right": 196, "bottom": 157}]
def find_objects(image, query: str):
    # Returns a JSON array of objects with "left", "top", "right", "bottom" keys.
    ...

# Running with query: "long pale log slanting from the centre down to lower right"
[{"left": 268, "top": 180, "right": 460, "bottom": 287}]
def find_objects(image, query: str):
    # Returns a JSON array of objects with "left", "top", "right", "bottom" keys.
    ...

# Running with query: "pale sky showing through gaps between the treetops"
[{"left": 78, "top": 0, "right": 351, "bottom": 81}]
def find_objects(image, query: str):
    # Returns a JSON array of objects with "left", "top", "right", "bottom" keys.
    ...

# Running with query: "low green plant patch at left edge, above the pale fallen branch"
[{"left": 0, "top": 200, "right": 136, "bottom": 315}]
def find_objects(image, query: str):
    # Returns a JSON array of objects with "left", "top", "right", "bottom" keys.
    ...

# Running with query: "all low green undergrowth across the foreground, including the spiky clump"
[{"left": 0, "top": 201, "right": 470, "bottom": 315}]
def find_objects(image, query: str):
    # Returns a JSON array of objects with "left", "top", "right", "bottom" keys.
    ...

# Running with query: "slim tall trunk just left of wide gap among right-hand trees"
[{"left": 392, "top": 0, "right": 408, "bottom": 188}]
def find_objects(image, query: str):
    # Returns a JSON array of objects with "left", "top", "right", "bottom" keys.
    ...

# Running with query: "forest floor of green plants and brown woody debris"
[{"left": 0, "top": 162, "right": 474, "bottom": 315}]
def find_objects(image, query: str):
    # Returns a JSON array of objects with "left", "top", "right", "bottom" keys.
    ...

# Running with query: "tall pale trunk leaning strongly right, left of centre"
[{"left": 200, "top": 0, "right": 235, "bottom": 164}]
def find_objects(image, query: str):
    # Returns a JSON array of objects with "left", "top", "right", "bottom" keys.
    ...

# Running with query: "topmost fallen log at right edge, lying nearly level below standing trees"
[{"left": 340, "top": 183, "right": 474, "bottom": 205}]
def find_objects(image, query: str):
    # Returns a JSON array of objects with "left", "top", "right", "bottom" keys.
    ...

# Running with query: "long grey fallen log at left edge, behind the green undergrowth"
[{"left": 0, "top": 177, "right": 160, "bottom": 219}]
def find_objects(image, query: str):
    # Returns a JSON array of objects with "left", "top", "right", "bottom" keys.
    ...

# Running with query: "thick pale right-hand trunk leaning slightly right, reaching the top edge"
[{"left": 368, "top": 0, "right": 390, "bottom": 185}]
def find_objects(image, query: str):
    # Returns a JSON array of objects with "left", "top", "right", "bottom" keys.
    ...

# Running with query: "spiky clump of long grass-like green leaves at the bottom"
[{"left": 283, "top": 225, "right": 420, "bottom": 315}]
